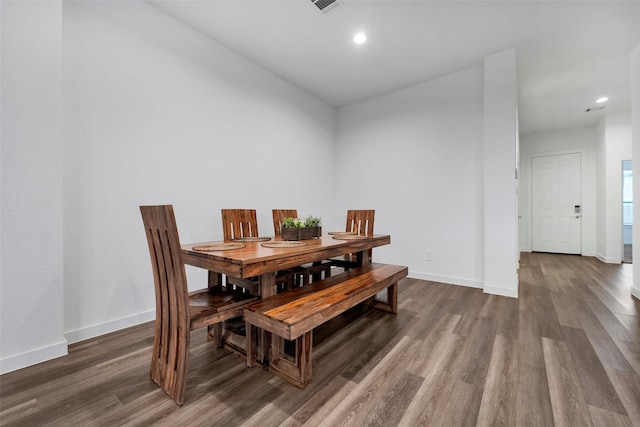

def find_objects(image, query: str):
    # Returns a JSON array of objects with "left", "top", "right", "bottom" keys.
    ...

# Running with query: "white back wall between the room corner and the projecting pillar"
[{"left": 336, "top": 67, "right": 484, "bottom": 287}]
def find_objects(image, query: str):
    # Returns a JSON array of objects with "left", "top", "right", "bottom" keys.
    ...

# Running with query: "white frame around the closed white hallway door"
[{"left": 518, "top": 148, "right": 595, "bottom": 256}]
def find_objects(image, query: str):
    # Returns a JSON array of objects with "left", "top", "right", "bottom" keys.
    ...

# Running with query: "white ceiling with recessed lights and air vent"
[{"left": 149, "top": 0, "right": 640, "bottom": 134}]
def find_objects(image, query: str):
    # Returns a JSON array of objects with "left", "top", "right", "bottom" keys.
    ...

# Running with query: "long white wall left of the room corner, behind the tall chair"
[{"left": 0, "top": 2, "right": 342, "bottom": 372}]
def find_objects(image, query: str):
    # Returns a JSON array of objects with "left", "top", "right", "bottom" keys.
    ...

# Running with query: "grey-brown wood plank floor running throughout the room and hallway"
[{"left": 0, "top": 253, "right": 640, "bottom": 427}]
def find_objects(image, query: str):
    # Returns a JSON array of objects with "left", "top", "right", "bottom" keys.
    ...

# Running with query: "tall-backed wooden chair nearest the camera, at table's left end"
[{"left": 140, "top": 205, "right": 257, "bottom": 405}]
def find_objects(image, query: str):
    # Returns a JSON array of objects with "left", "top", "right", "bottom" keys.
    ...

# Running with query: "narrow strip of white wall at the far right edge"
[{"left": 630, "top": 42, "right": 640, "bottom": 299}]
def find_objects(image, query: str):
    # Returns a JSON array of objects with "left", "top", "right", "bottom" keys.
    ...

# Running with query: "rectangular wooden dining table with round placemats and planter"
[{"left": 182, "top": 234, "right": 391, "bottom": 363}]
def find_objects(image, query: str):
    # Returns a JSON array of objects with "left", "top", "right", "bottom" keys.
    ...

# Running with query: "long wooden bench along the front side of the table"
[{"left": 244, "top": 263, "right": 408, "bottom": 388}]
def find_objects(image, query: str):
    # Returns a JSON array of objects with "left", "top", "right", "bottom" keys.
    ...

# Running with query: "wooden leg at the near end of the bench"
[{"left": 269, "top": 331, "right": 313, "bottom": 388}]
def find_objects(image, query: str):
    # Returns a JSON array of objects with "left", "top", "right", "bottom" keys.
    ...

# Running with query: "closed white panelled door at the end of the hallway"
[{"left": 531, "top": 153, "right": 582, "bottom": 254}]
